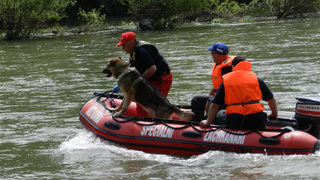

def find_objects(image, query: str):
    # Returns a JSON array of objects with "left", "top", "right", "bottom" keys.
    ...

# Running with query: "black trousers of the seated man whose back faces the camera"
[{"left": 226, "top": 112, "right": 267, "bottom": 130}]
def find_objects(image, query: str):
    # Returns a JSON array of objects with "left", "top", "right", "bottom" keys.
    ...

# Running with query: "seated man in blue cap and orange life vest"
[{"left": 191, "top": 42, "right": 236, "bottom": 121}]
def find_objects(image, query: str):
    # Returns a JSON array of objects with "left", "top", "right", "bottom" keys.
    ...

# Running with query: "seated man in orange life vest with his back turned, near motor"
[{"left": 200, "top": 59, "right": 278, "bottom": 130}]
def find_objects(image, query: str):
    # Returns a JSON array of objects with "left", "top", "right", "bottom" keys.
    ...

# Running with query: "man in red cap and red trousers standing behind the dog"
[{"left": 113, "top": 32, "right": 172, "bottom": 117}]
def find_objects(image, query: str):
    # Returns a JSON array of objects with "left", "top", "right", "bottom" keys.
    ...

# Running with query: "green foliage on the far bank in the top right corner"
[{"left": 249, "top": 0, "right": 320, "bottom": 19}]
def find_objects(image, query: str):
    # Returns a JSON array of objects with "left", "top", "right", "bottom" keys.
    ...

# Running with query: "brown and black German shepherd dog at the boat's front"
[{"left": 102, "top": 58, "right": 194, "bottom": 120}]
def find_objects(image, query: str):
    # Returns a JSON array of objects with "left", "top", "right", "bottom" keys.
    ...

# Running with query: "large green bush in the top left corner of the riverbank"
[{"left": 0, "top": 0, "right": 76, "bottom": 40}]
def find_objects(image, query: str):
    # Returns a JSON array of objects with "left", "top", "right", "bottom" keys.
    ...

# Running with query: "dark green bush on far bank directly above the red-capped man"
[{"left": 120, "top": 0, "right": 209, "bottom": 29}]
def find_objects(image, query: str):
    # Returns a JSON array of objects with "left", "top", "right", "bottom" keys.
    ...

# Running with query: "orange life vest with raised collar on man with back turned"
[{"left": 223, "top": 61, "right": 264, "bottom": 115}]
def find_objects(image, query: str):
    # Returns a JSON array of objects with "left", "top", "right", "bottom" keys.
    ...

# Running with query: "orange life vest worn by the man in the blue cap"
[{"left": 211, "top": 56, "right": 236, "bottom": 94}]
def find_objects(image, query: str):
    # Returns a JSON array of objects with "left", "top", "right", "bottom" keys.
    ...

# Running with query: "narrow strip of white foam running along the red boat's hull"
[{"left": 59, "top": 130, "right": 320, "bottom": 160}]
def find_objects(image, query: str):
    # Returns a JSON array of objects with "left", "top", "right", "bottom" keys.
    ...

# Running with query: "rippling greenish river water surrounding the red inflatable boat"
[{"left": 0, "top": 16, "right": 320, "bottom": 180}]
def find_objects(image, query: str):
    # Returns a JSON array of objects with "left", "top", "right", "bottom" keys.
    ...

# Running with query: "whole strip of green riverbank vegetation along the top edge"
[{"left": 0, "top": 0, "right": 320, "bottom": 40}]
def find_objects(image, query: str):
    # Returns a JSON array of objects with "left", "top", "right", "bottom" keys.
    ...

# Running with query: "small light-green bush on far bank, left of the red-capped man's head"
[{"left": 78, "top": 6, "right": 106, "bottom": 27}]
